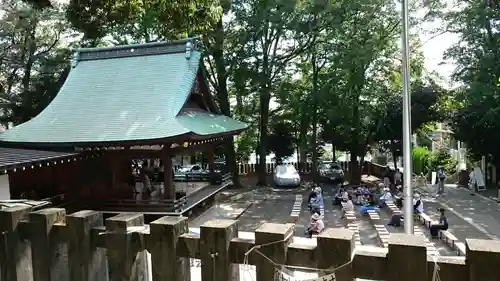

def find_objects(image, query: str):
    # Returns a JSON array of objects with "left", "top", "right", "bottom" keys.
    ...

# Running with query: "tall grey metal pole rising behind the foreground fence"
[{"left": 401, "top": 0, "right": 413, "bottom": 234}]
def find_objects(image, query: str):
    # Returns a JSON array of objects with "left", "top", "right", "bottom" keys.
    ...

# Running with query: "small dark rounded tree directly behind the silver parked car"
[{"left": 267, "top": 122, "right": 294, "bottom": 164}]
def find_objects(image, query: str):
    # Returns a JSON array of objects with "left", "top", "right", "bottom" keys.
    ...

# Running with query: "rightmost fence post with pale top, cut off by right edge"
[{"left": 465, "top": 238, "right": 500, "bottom": 281}]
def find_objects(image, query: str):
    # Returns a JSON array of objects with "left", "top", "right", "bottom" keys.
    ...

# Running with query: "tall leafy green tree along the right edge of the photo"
[{"left": 446, "top": 0, "right": 500, "bottom": 170}]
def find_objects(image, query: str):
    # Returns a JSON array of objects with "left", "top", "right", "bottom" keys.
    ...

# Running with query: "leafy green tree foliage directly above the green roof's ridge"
[{"left": 66, "top": 0, "right": 222, "bottom": 46}]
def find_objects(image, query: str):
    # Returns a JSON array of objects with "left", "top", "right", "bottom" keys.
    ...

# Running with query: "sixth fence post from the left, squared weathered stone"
[{"left": 200, "top": 220, "right": 239, "bottom": 281}]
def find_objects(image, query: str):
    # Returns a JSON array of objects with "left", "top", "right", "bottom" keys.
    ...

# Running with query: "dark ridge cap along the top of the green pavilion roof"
[{"left": 72, "top": 37, "right": 199, "bottom": 62}]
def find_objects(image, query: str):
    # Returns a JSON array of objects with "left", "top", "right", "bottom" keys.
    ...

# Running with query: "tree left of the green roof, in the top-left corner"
[{"left": 0, "top": 2, "right": 74, "bottom": 126}]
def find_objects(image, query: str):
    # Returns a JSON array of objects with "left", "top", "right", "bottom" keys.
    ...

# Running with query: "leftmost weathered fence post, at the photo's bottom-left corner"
[{"left": 0, "top": 206, "right": 33, "bottom": 281}]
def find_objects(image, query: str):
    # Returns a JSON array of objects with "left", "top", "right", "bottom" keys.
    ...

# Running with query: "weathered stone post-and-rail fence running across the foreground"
[{"left": 0, "top": 207, "right": 500, "bottom": 281}]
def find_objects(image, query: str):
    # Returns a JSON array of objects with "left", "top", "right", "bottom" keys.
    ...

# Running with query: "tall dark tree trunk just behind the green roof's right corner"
[{"left": 213, "top": 17, "right": 241, "bottom": 187}]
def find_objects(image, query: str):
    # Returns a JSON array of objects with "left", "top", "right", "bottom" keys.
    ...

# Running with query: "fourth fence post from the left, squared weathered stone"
[{"left": 106, "top": 214, "right": 147, "bottom": 281}]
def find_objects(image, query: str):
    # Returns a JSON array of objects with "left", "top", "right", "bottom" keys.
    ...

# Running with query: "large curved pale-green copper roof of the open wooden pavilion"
[{"left": 0, "top": 38, "right": 246, "bottom": 145}]
